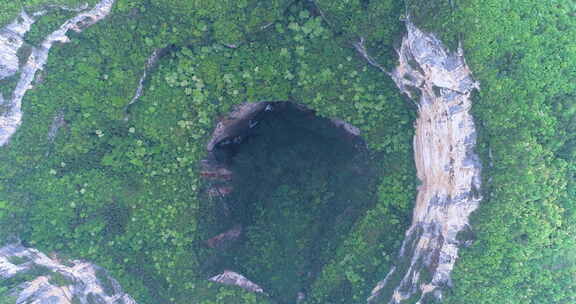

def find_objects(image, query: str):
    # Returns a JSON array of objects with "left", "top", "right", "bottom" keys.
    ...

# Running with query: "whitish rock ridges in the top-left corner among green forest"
[{"left": 0, "top": 0, "right": 115, "bottom": 146}]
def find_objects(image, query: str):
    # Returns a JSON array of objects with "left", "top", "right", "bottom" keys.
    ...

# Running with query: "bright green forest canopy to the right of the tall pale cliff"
[{"left": 412, "top": 0, "right": 576, "bottom": 304}]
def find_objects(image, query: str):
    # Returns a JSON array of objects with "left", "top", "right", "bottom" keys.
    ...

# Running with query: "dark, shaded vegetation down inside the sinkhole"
[{"left": 210, "top": 104, "right": 402, "bottom": 303}]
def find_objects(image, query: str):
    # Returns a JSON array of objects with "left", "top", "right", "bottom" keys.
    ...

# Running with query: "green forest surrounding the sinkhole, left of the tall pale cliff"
[{"left": 0, "top": 1, "right": 415, "bottom": 303}]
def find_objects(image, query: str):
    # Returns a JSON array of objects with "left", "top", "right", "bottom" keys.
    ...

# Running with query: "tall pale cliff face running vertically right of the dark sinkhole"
[{"left": 368, "top": 21, "right": 482, "bottom": 303}]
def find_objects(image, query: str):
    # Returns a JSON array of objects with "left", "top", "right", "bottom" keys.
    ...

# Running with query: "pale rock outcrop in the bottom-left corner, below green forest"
[{"left": 0, "top": 244, "right": 136, "bottom": 304}]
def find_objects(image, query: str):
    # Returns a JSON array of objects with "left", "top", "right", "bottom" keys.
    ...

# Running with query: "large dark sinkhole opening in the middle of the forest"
[{"left": 202, "top": 102, "right": 382, "bottom": 303}]
